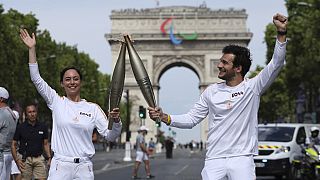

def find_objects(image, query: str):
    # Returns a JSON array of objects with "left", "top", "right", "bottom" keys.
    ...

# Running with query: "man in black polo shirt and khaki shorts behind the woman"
[{"left": 11, "top": 104, "right": 51, "bottom": 180}]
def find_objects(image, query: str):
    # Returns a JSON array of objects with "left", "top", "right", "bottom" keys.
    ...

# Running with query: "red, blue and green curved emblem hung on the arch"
[{"left": 160, "top": 17, "right": 198, "bottom": 45}]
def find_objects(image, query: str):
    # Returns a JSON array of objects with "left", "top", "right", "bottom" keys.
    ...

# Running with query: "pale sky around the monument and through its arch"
[{"left": 0, "top": 0, "right": 287, "bottom": 143}]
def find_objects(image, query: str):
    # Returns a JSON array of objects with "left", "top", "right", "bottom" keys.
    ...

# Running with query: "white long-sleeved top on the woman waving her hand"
[{"left": 29, "top": 63, "right": 122, "bottom": 158}]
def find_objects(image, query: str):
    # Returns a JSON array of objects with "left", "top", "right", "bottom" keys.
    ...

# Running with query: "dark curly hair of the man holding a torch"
[{"left": 222, "top": 44, "right": 252, "bottom": 77}]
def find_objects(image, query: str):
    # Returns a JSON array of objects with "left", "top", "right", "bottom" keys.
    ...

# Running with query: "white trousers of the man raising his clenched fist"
[{"left": 201, "top": 155, "right": 256, "bottom": 180}]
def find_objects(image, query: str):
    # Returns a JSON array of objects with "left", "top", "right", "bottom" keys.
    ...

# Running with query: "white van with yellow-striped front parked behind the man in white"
[{"left": 254, "top": 123, "right": 320, "bottom": 179}]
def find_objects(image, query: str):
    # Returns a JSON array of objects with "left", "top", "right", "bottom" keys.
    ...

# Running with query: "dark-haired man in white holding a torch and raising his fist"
[{"left": 148, "top": 14, "right": 287, "bottom": 180}]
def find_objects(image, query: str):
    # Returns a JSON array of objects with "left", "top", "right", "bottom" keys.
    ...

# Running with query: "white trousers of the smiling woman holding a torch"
[{"left": 48, "top": 156, "right": 94, "bottom": 180}]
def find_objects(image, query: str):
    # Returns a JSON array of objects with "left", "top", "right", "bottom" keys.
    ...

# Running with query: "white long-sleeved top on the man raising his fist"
[{"left": 171, "top": 40, "right": 286, "bottom": 160}]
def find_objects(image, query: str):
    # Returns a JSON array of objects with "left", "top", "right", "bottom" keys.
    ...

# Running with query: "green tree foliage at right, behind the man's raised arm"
[{"left": 252, "top": 0, "right": 320, "bottom": 122}]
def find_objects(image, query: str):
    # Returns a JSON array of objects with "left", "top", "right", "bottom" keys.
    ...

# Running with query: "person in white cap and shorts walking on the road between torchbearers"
[{"left": 132, "top": 126, "right": 154, "bottom": 179}]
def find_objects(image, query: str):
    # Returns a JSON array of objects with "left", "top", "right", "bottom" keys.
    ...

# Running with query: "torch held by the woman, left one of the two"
[{"left": 108, "top": 42, "right": 126, "bottom": 130}]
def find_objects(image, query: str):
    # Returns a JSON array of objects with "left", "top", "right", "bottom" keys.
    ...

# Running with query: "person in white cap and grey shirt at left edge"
[{"left": 0, "top": 87, "right": 17, "bottom": 180}]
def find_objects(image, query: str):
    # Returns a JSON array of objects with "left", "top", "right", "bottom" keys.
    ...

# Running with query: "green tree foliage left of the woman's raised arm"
[{"left": 0, "top": 7, "right": 38, "bottom": 108}]
